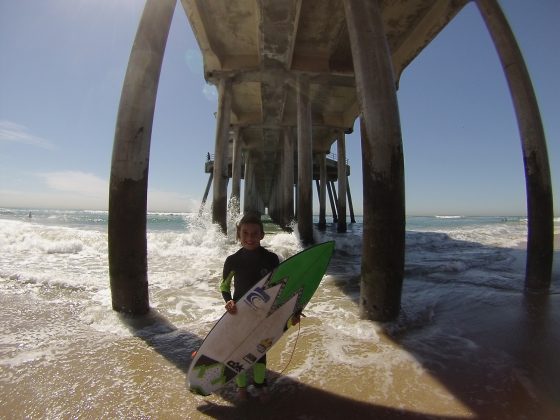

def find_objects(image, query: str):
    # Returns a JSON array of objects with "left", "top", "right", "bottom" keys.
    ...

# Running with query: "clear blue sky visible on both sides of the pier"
[{"left": 0, "top": 0, "right": 560, "bottom": 215}]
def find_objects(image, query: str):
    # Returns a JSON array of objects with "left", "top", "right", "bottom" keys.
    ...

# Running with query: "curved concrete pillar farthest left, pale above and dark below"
[{"left": 108, "top": 0, "right": 176, "bottom": 315}]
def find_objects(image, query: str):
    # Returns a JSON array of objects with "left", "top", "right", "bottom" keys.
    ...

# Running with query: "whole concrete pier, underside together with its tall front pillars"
[{"left": 109, "top": 0, "right": 553, "bottom": 321}]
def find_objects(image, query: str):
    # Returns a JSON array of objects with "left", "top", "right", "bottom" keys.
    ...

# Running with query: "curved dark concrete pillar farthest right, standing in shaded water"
[{"left": 476, "top": 0, "right": 554, "bottom": 292}]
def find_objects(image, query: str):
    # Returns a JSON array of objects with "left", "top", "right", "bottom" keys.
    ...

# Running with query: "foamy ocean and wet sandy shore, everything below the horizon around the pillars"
[{"left": 0, "top": 208, "right": 560, "bottom": 419}]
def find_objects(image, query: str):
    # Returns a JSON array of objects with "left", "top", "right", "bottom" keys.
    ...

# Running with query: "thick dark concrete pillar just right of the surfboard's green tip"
[{"left": 343, "top": 0, "right": 405, "bottom": 321}]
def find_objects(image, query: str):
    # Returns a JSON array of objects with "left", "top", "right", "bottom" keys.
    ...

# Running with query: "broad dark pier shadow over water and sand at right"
[{"left": 330, "top": 232, "right": 560, "bottom": 420}]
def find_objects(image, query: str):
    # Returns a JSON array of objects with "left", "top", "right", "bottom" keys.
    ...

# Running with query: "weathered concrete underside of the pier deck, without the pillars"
[{"left": 181, "top": 0, "right": 467, "bottom": 217}]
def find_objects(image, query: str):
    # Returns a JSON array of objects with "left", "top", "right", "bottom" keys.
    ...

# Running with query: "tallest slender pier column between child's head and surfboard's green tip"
[{"left": 297, "top": 75, "right": 313, "bottom": 244}]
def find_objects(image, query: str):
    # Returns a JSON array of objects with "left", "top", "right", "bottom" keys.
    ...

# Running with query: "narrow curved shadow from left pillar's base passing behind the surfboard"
[{"left": 120, "top": 309, "right": 464, "bottom": 420}]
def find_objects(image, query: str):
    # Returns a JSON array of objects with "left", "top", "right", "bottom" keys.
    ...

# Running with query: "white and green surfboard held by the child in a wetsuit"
[{"left": 187, "top": 241, "right": 334, "bottom": 395}]
